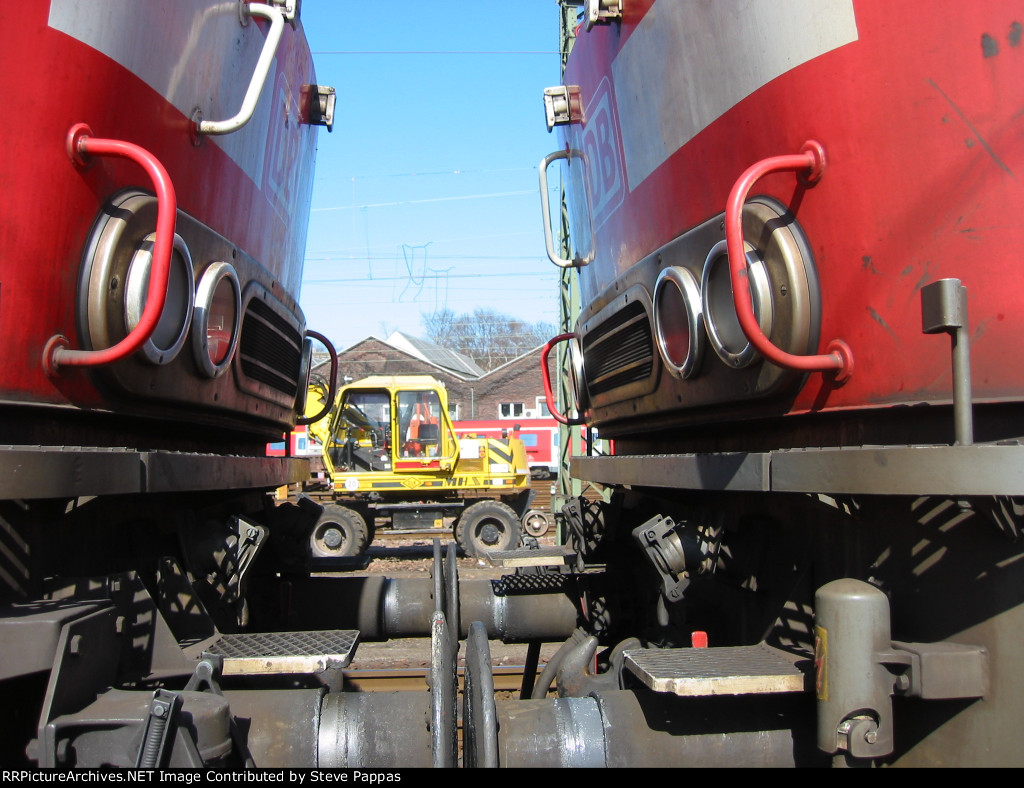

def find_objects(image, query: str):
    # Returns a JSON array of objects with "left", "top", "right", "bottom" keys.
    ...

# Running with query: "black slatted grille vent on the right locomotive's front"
[{"left": 583, "top": 301, "right": 654, "bottom": 396}]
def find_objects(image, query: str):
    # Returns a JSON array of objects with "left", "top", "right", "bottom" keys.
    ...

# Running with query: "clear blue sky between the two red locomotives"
[{"left": 301, "top": 0, "right": 559, "bottom": 350}]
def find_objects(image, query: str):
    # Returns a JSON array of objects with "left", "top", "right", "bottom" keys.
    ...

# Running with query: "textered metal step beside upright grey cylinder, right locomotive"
[{"left": 624, "top": 643, "right": 814, "bottom": 697}]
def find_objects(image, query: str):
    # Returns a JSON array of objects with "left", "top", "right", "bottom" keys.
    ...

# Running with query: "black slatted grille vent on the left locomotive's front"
[{"left": 239, "top": 298, "right": 302, "bottom": 397}]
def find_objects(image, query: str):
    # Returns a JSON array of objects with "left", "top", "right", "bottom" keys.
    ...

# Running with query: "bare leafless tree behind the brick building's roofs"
[{"left": 422, "top": 308, "right": 556, "bottom": 370}]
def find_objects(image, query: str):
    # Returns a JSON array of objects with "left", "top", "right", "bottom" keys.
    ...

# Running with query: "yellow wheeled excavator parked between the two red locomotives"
[{"left": 307, "top": 375, "right": 534, "bottom": 560}]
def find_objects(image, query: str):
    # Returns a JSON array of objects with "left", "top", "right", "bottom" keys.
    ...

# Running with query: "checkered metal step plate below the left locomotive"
[{"left": 204, "top": 629, "right": 359, "bottom": 675}]
